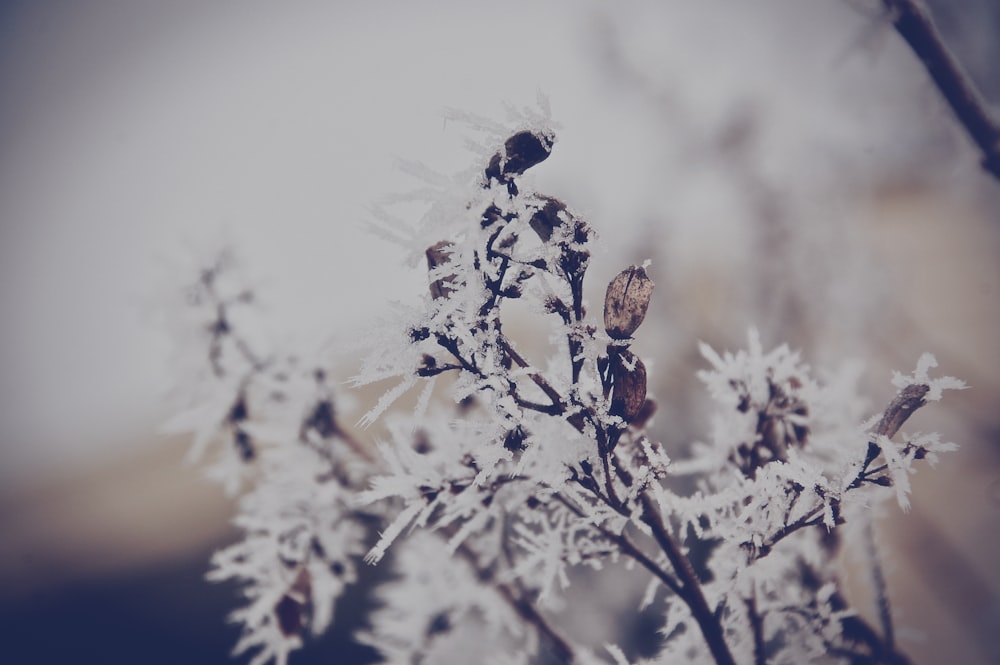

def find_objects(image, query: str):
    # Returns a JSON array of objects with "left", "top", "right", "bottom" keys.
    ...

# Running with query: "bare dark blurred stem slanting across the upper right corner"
[{"left": 882, "top": 0, "right": 1000, "bottom": 180}]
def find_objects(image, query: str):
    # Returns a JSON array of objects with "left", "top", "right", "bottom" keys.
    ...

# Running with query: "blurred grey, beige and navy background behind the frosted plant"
[{"left": 0, "top": 0, "right": 1000, "bottom": 665}]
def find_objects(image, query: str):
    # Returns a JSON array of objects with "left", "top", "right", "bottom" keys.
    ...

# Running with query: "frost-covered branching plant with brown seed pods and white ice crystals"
[{"left": 162, "top": 113, "right": 963, "bottom": 665}]
